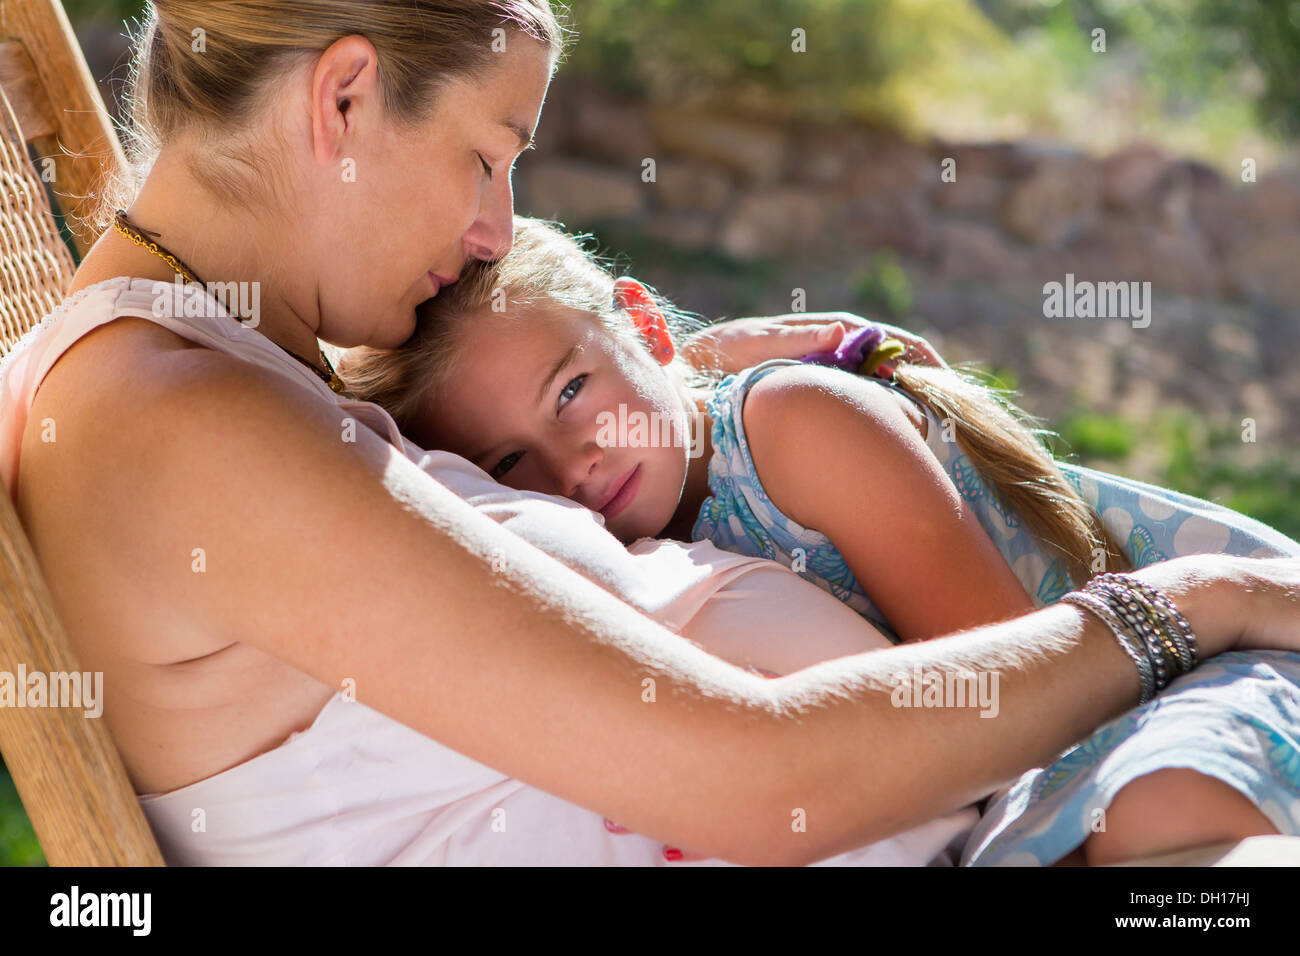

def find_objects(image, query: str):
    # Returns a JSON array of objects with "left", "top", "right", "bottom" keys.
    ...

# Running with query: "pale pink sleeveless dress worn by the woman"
[{"left": 0, "top": 277, "right": 976, "bottom": 866}]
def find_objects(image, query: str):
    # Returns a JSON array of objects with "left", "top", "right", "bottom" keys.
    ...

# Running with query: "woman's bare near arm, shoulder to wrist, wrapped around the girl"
[{"left": 76, "top": 350, "right": 1284, "bottom": 864}]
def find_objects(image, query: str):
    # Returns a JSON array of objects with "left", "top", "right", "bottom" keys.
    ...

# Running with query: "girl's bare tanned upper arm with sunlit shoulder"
[{"left": 742, "top": 365, "right": 1034, "bottom": 640}]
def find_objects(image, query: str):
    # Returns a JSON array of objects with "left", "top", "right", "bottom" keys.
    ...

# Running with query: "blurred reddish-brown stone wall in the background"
[{"left": 516, "top": 78, "right": 1300, "bottom": 450}]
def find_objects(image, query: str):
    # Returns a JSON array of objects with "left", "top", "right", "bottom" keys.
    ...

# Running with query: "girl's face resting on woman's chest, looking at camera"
[{"left": 411, "top": 302, "right": 690, "bottom": 541}]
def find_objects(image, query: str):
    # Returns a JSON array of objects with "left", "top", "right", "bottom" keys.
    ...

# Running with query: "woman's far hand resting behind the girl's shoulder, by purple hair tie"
[{"left": 681, "top": 312, "right": 946, "bottom": 377}]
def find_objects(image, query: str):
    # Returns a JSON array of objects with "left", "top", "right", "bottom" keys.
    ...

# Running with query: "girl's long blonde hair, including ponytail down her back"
[{"left": 337, "top": 216, "right": 1128, "bottom": 585}]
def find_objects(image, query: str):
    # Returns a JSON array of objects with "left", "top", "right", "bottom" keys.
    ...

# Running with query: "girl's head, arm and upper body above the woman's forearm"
[{"left": 339, "top": 217, "right": 1294, "bottom": 640}]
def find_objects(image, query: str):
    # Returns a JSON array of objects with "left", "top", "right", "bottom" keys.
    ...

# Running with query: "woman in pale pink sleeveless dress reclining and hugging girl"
[{"left": 3, "top": 0, "right": 1300, "bottom": 862}]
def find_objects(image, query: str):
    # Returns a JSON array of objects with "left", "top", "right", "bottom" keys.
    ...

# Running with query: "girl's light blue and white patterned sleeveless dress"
[{"left": 693, "top": 360, "right": 1300, "bottom": 865}]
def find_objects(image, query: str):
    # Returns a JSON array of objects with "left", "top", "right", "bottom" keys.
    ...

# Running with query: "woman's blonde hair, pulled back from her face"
[{"left": 95, "top": 0, "right": 564, "bottom": 228}]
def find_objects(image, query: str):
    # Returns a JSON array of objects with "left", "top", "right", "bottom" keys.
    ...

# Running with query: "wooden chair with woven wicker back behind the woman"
[{"left": 0, "top": 0, "right": 163, "bottom": 866}]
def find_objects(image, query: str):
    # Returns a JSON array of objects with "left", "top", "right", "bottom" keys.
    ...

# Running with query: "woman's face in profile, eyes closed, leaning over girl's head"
[{"left": 308, "top": 34, "right": 553, "bottom": 349}]
